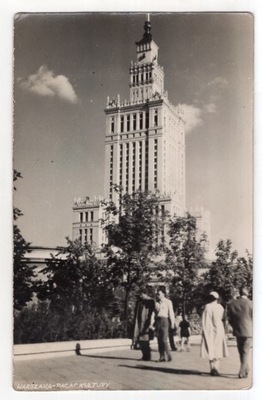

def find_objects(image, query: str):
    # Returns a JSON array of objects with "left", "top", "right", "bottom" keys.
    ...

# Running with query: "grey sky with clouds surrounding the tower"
[{"left": 14, "top": 13, "right": 254, "bottom": 255}]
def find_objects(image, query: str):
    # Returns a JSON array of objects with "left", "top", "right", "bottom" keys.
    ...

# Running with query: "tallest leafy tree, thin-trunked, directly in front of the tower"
[{"left": 102, "top": 186, "right": 165, "bottom": 332}]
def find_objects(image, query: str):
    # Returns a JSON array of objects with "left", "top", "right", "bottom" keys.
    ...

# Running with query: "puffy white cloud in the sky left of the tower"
[{"left": 18, "top": 65, "right": 78, "bottom": 104}]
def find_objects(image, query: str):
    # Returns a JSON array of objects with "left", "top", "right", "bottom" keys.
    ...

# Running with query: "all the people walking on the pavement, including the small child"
[{"left": 133, "top": 286, "right": 253, "bottom": 378}]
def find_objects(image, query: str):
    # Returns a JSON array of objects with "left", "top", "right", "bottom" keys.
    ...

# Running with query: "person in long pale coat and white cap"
[{"left": 200, "top": 292, "right": 228, "bottom": 376}]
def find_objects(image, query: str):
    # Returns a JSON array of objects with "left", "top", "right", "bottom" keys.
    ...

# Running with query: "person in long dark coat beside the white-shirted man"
[{"left": 133, "top": 287, "right": 155, "bottom": 361}]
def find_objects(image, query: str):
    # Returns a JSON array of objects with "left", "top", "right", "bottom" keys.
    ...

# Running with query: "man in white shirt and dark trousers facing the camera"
[{"left": 156, "top": 286, "right": 175, "bottom": 362}]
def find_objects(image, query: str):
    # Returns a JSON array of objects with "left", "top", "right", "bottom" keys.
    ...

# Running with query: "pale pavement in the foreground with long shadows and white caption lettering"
[{"left": 13, "top": 340, "right": 252, "bottom": 391}]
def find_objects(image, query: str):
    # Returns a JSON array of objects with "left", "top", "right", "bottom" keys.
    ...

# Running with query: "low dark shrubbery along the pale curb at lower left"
[{"left": 14, "top": 302, "right": 128, "bottom": 344}]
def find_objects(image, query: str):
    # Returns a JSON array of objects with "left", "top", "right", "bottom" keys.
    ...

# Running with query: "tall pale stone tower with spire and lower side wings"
[{"left": 73, "top": 18, "right": 210, "bottom": 250}]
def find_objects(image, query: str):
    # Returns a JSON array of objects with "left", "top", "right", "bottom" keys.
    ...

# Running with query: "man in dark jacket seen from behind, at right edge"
[{"left": 227, "top": 287, "right": 253, "bottom": 378}]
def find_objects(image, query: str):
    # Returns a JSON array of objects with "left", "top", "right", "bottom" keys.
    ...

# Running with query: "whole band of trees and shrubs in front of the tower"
[{"left": 14, "top": 177, "right": 253, "bottom": 343}]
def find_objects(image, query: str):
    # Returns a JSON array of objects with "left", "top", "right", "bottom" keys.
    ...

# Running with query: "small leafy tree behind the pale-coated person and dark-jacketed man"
[{"left": 204, "top": 239, "right": 253, "bottom": 302}]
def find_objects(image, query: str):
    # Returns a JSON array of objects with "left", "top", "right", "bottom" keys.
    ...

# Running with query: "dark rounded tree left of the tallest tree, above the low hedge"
[{"left": 35, "top": 238, "right": 112, "bottom": 313}]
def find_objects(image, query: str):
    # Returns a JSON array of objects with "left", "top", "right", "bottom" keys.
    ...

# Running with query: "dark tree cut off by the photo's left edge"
[{"left": 13, "top": 170, "right": 35, "bottom": 310}]
